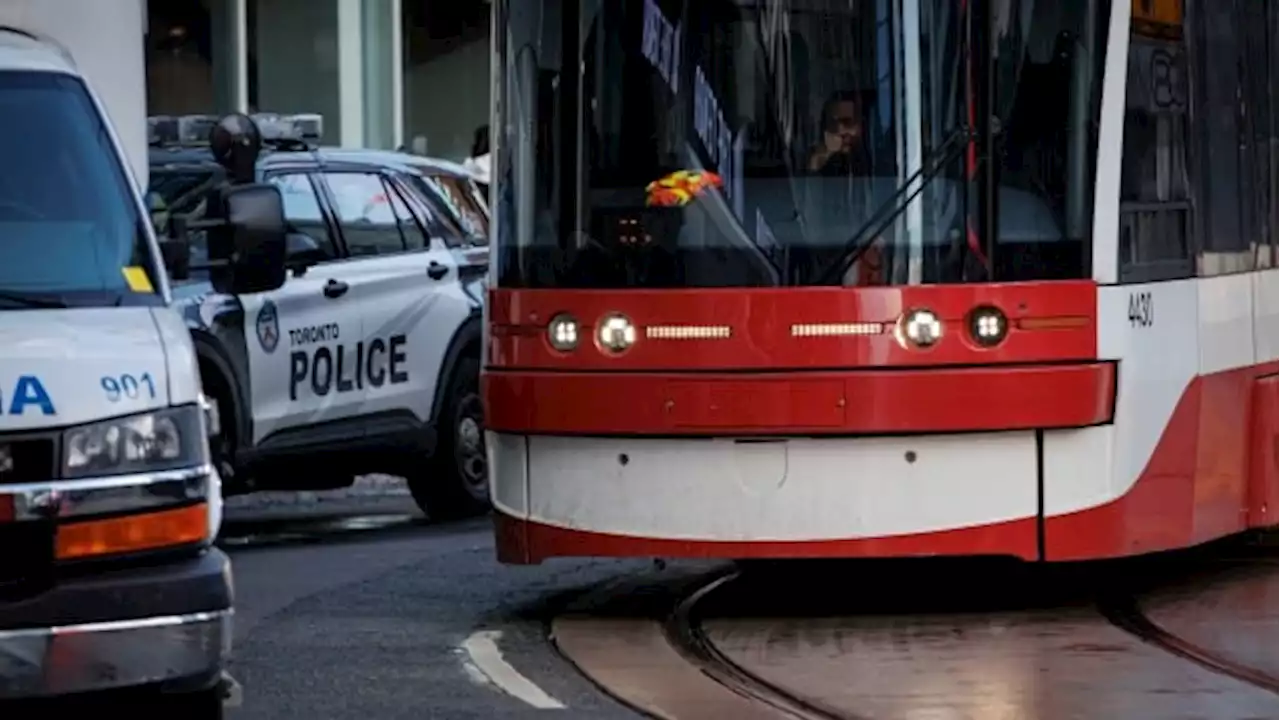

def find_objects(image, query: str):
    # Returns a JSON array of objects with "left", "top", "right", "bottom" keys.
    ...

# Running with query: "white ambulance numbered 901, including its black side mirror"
[{"left": 0, "top": 0, "right": 284, "bottom": 717}]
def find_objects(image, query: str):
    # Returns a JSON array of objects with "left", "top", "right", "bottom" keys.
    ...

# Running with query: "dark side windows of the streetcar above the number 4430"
[{"left": 1119, "top": 0, "right": 1280, "bottom": 282}]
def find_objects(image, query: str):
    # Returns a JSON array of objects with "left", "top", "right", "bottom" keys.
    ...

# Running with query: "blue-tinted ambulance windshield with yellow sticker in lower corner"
[{"left": 0, "top": 72, "right": 160, "bottom": 310}]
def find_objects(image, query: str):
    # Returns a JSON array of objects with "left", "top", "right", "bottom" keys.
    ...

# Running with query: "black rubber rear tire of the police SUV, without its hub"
[{"left": 407, "top": 359, "right": 489, "bottom": 520}]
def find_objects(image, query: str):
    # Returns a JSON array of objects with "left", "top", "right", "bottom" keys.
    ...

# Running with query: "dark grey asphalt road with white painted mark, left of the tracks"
[{"left": 223, "top": 497, "right": 650, "bottom": 720}]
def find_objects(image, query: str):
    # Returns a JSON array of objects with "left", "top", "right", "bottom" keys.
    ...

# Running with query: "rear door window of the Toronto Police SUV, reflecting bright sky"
[{"left": 325, "top": 172, "right": 408, "bottom": 258}]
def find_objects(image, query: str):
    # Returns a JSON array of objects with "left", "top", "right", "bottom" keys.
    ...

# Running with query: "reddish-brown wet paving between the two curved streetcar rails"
[{"left": 707, "top": 579, "right": 1280, "bottom": 720}]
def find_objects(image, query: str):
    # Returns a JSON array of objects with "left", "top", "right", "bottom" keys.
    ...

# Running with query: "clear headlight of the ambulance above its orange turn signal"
[{"left": 61, "top": 405, "right": 209, "bottom": 478}]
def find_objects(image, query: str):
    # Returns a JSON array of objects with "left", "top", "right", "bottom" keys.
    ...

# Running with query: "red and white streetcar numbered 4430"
[{"left": 483, "top": 0, "right": 1280, "bottom": 564}]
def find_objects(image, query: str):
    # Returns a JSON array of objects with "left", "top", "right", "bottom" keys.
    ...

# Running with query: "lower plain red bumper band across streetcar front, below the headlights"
[{"left": 483, "top": 363, "right": 1115, "bottom": 436}]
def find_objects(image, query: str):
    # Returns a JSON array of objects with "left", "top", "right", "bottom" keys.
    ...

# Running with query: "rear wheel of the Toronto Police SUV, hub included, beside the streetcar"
[{"left": 408, "top": 359, "right": 489, "bottom": 520}]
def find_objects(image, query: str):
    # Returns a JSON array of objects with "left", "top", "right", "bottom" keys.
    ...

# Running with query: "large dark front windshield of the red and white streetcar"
[{"left": 494, "top": 0, "right": 1106, "bottom": 287}]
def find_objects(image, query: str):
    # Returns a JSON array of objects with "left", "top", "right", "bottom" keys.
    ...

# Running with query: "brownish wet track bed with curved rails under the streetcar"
[{"left": 556, "top": 544, "right": 1280, "bottom": 720}]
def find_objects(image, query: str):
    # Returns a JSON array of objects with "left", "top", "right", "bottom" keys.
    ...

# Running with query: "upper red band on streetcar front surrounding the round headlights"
[{"left": 488, "top": 281, "right": 1097, "bottom": 372}]
